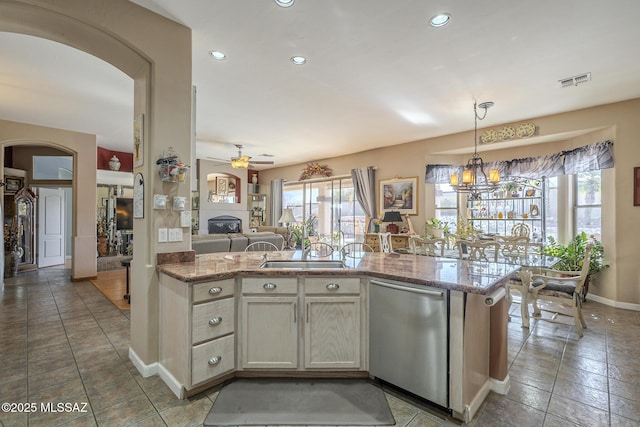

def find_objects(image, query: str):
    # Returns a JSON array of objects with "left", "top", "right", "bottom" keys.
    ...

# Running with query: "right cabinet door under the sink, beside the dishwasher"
[{"left": 304, "top": 296, "right": 360, "bottom": 369}]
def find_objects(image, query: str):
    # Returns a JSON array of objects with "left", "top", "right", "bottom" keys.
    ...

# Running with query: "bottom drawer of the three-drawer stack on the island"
[{"left": 191, "top": 335, "right": 235, "bottom": 385}]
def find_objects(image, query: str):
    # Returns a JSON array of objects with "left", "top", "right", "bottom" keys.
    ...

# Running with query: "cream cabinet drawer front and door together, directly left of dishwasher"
[{"left": 303, "top": 276, "right": 363, "bottom": 369}]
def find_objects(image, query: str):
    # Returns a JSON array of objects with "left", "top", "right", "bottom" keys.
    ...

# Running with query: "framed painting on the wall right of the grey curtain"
[{"left": 378, "top": 176, "right": 418, "bottom": 215}]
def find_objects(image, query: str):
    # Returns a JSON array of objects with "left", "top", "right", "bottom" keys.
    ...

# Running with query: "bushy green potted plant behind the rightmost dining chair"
[{"left": 541, "top": 231, "right": 609, "bottom": 299}]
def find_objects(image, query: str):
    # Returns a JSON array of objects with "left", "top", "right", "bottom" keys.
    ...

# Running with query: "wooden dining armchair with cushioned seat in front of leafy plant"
[{"left": 521, "top": 244, "right": 593, "bottom": 337}]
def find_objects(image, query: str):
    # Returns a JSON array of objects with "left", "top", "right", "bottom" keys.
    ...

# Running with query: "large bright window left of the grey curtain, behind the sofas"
[{"left": 283, "top": 178, "right": 366, "bottom": 246}]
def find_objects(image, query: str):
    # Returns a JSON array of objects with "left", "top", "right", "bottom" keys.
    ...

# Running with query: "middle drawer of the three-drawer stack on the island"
[{"left": 191, "top": 298, "right": 235, "bottom": 344}]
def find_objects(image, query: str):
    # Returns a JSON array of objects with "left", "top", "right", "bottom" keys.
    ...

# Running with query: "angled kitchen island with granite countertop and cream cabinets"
[{"left": 157, "top": 251, "right": 517, "bottom": 421}]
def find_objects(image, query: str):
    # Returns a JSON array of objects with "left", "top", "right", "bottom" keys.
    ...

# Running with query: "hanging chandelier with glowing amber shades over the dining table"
[{"left": 449, "top": 101, "right": 500, "bottom": 198}]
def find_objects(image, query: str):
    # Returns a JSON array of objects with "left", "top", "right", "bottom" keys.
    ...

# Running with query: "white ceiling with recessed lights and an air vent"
[{"left": 0, "top": 0, "right": 640, "bottom": 166}]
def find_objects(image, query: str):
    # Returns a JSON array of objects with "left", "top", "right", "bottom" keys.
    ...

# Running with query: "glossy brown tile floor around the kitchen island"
[{"left": 0, "top": 268, "right": 640, "bottom": 427}]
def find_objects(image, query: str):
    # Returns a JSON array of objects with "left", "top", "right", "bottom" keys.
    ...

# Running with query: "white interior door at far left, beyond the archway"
[{"left": 38, "top": 188, "right": 65, "bottom": 268}]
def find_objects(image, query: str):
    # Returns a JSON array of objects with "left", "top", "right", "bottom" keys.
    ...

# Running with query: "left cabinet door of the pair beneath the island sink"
[{"left": 242, "top": 296, "right": 298, "bottom": 369}]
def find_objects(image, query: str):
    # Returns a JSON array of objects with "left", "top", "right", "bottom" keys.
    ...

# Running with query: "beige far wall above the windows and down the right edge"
[{"left": 260, "top": 99, "right": 640, "bottom": 309}]
